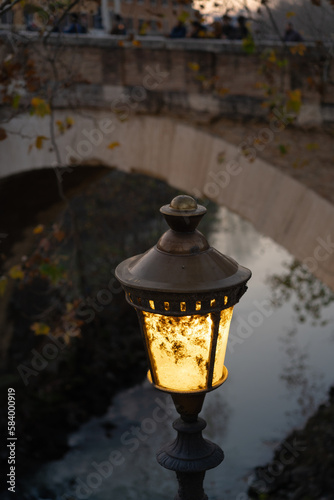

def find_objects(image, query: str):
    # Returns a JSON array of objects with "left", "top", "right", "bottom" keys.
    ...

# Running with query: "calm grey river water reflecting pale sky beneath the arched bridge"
[{"left": 21, "top": 204, "right": 334, "bottom": 500}]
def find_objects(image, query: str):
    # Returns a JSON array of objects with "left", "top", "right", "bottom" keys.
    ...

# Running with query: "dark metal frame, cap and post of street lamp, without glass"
[{"left": 116, "top": 195, "right": 251, "bottom": 500}]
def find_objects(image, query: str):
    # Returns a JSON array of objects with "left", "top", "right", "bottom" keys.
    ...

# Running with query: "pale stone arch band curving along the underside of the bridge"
[{"left": 0, "top": 109, "right": 334, "bottom": 288}]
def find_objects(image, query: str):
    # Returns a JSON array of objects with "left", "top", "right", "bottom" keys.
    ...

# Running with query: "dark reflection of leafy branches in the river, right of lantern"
[{"left": 268, "top": 259, "right": 334, "bottom": 422}]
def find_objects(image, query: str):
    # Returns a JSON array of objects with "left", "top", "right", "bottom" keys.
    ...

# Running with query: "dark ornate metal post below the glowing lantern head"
[{"left": 157, "top": 394, "right": 224, "bottom": 500}]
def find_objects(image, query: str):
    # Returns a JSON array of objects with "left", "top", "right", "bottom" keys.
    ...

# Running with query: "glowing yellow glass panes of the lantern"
[{"left": 143, "top": 307, "right": 233, "bottom": 391}]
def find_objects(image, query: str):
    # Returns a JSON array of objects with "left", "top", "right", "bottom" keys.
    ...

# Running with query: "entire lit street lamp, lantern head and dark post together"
[{"left": 116, "top": 195, "right": 251, "bottom": 500}]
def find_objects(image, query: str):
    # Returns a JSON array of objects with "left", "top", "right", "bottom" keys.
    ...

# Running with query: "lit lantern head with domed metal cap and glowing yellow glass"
[{"left": 116, "top": 195, "right": 251, "bottom": 394}]
